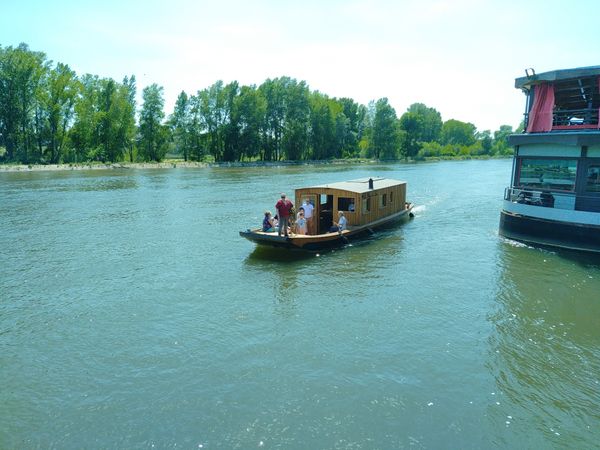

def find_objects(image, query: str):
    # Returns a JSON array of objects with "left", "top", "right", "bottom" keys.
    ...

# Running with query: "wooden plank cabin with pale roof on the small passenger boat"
[{"left": 295, "top": 178, "right": 406, "bottom": 234}]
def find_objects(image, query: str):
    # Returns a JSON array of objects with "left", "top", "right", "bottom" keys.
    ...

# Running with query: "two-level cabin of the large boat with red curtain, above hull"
[{"left": 509, "top": 66, "right": 600, "bottom": 212}]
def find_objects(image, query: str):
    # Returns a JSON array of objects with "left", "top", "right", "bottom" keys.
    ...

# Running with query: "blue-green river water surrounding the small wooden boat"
[{"left": 0, "top": 160, "right": 600, "bottom": 449}]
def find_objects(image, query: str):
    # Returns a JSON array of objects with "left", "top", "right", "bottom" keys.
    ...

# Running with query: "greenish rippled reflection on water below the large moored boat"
[{"left": 488, "top": 244, "right": 600, "bottom": 448}]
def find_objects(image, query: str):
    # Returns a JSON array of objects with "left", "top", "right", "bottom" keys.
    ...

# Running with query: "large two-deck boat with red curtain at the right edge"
[{"left": 500, "top": 66, "right": 600, "bottom": 253}]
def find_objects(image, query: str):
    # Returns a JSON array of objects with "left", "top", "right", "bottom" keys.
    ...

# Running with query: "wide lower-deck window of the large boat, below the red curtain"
[{"left": 517, "top": 158, "right": 577, "bottom": 191}]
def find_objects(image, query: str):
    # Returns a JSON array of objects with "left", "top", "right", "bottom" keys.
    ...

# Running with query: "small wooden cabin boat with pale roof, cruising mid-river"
[{"left": 240, "top": 178, "right": 413, "bottom": 250}]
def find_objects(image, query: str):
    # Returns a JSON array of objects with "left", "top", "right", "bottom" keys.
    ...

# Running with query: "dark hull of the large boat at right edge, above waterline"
[{"left": 500, "top": 210, "right": 600, "bottom": 253}]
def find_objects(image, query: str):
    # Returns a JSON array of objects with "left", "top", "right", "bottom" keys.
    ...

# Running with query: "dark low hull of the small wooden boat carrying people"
[{"left": 240, "top": 205, "right": 413, "bottom": 251}]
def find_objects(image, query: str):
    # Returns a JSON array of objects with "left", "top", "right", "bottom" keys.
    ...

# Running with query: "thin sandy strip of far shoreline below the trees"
[{"left": 0, "top": 155, "right": 512, "bottom": 173}]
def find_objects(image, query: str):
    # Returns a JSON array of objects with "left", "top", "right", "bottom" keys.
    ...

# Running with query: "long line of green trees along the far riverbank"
[{"left": 0, "top": 44, "right": 513, "bottom": 164}]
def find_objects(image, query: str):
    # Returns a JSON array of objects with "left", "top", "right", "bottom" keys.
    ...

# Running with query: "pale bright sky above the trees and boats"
[{"left": 0, "top": 0, "right": 600, "bottom": 132}]
